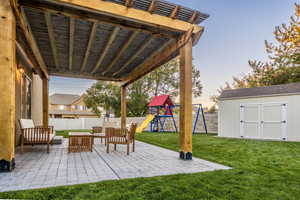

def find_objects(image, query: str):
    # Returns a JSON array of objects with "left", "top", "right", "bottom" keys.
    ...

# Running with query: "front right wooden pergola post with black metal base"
[{"left": 179, "top": 39, "right": 193, "bottom": 160}]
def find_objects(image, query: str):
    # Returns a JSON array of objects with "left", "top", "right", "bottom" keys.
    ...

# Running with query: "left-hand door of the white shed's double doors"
[{"left": 240, "top": 104, "right": 260, "bottom": 138}]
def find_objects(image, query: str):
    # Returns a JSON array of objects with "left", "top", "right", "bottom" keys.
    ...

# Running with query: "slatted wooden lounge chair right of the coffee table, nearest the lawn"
[{"left": 105, "top": 124, "right": 137, "bottom": 155}]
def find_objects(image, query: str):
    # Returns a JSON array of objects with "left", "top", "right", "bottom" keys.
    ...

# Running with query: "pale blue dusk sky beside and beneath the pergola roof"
[{"left": 50, "top": 0, "right": 299, "bottom": 108}]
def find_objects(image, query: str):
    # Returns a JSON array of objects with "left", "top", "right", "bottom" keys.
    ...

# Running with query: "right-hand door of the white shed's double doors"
[{"left": 261, "top": 103, "right": 287, "bottom": 139}]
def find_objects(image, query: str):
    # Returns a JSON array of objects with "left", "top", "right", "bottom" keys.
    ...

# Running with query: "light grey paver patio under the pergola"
[{"left": 0, "top": 139, "right": 230, "bottom": 192}]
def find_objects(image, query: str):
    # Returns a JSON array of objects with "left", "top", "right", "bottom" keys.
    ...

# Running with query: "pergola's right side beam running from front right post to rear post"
[{"left": 123, "top": 26, "right": 193, "bottom": 86}]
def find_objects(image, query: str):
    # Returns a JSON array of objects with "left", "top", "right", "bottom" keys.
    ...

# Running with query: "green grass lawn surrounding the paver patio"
[{"left": 0, "top": 133, "right": 300, "bottom": 200}]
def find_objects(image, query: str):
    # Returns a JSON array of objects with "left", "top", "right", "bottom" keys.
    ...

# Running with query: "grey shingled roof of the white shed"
[{"left": 219, "top": 82, "right": 300, "bottom": 100}]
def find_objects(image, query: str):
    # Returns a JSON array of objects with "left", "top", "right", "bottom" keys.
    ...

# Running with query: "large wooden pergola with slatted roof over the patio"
[{"left": 0, "top": 0, "right": 208, "bottom": 170}]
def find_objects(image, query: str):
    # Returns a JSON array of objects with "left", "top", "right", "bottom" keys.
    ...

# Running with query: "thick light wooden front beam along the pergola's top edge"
[{"left": 48, "top": 0, "right": 201, "bottom": 33}]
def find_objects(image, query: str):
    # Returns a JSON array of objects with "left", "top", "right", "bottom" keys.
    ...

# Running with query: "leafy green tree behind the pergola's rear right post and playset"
[{"left": 85, "top": 58, "right": 202, "bottom": 117}]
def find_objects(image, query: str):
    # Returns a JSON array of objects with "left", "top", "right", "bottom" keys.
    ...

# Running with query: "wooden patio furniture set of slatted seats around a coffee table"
[{"left": 20, "top": 119, "right": 137, "bottom": 155}]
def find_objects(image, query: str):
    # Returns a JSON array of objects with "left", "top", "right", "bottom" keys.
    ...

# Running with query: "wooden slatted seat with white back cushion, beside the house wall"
[{"left": 20, "top": 119, "right": 55, "bottom": 153}]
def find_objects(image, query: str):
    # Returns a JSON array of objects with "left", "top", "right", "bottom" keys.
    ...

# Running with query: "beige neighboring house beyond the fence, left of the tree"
[{"left": 49, "top": 94, "right": 97, "bottom": 119}]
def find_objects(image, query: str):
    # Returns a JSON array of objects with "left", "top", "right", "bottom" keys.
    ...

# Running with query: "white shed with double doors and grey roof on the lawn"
[{"left": 218, "top": 83, "right": 300, "bottom": 141}]
